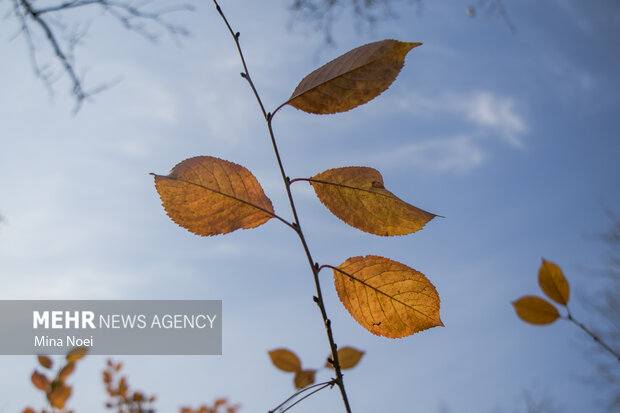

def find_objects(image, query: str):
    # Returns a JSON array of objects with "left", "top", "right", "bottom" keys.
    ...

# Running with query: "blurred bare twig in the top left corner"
[{"left": 13, "top": 0, "right": 193, "bottom": 112}]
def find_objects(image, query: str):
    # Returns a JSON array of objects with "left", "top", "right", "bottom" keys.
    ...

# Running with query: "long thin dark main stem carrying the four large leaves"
[{"left": 213, "top": 0, "right": 351, "bottom": 413}]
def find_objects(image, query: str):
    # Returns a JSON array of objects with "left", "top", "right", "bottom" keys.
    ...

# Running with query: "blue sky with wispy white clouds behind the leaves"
[{"left": 0, "top": 0, "right": 620, "bottom": 413}]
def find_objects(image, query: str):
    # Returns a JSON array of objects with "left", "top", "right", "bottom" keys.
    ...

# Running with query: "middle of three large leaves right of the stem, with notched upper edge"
[{"left": 310, "top": 166, "right": 436, "bottom": 236}]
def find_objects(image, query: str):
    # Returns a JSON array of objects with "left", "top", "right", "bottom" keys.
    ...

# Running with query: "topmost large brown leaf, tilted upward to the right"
[{"left": 278, "top": 40, "right": 422, "bottom": 114}]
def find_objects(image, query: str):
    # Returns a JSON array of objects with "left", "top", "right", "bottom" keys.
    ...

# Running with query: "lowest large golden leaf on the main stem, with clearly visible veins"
[{"left": 334, "top": 255, "right": 443, "bottom": 338}]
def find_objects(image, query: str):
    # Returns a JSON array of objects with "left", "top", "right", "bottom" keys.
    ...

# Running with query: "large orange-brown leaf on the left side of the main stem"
[{"left": 155, "top": 156, "right": 274, "bottom": 236}]
